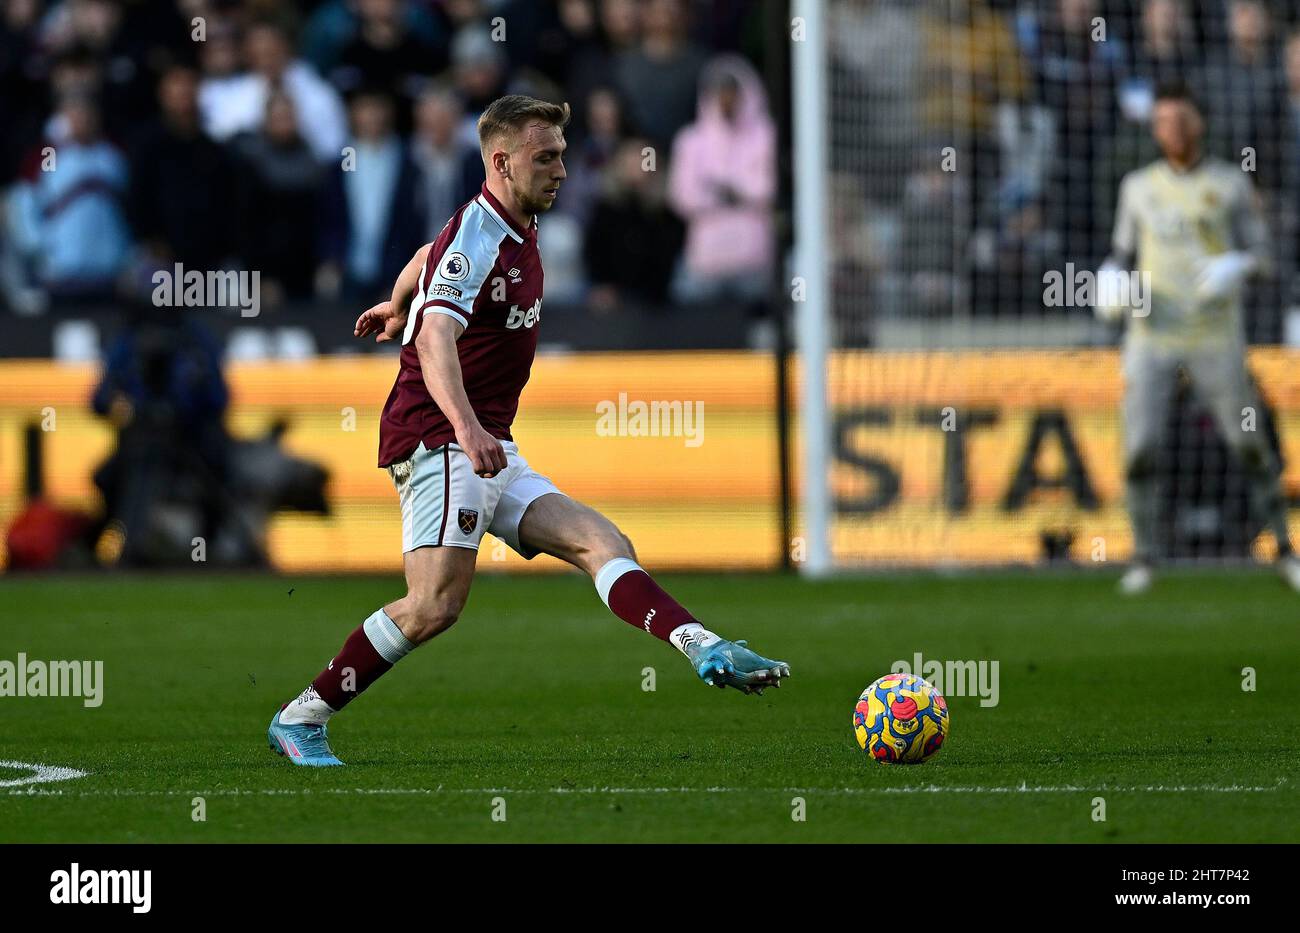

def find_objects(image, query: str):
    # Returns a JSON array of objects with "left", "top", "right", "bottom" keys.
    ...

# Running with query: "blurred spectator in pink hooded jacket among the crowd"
[{"left": 668, "top": 56, "right": 776, "bottom": 303}]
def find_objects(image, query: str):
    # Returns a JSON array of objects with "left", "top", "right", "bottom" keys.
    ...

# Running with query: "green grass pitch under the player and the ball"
[{"left": 0, "top": 572, "right": 1300, "bottom": 842}]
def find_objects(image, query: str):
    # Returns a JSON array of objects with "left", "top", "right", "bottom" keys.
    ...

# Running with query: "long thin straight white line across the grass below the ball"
[{"left": 8, "top": 778, "right": 1287, "bottom": 797}]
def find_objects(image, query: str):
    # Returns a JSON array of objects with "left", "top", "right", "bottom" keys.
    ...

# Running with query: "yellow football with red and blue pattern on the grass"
[{"left": 853, "top": 673, "right": 948, "bottom": 764}]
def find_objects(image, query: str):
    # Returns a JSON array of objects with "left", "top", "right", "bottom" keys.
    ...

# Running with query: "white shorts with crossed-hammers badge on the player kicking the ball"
[{"left": 387, "top": 441, "right": 559, "bottom": 560}]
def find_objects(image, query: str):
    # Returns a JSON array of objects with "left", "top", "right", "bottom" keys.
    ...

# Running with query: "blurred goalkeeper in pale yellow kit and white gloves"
[{"left": 1097, "top": 78, "right": 1300, "bottom": 595}]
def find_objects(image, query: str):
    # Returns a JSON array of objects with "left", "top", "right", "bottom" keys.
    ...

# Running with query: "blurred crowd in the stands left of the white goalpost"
[{"left": 0, "top": 0, "right": 776, "bottom": 322}]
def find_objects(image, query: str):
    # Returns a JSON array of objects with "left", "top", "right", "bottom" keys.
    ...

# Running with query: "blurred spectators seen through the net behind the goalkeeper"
[{"left": 828, "top": 0, "right": 1300, "bottom": 340}]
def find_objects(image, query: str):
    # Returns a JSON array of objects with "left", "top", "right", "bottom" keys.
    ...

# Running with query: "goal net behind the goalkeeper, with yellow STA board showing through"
[{"left": 793, "top": 0, "right": 1300, "bottom": 569}]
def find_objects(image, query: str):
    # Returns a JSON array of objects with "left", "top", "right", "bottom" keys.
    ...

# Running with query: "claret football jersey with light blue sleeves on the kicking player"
[{"left": 380, "top": 185, "right": 542, "bottom": 467}]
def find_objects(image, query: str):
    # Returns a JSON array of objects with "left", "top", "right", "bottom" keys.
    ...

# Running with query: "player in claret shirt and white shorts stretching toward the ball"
[{"left": 268, "top": 95, "right": 790, "bottom": 765}]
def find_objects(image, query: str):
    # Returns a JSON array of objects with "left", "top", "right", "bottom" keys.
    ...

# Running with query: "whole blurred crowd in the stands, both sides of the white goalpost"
[{"left": 12, "top": 0, "right": 1300, "bottom": 343}]
